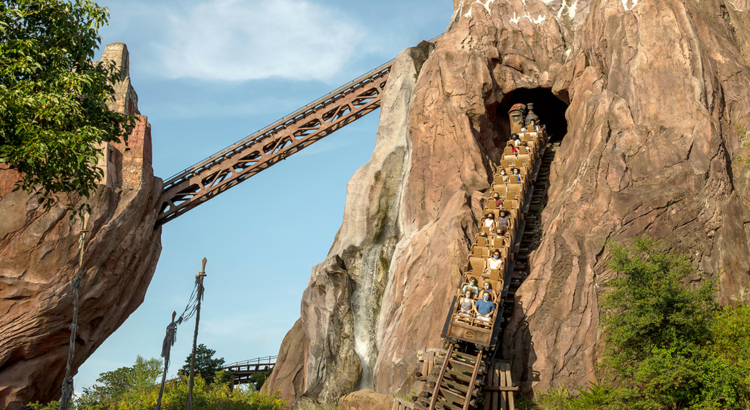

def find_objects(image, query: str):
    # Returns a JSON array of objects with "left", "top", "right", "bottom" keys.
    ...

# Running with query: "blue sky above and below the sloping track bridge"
[{"left": 76, "top": 0, "right": 453, "bottom": 391}]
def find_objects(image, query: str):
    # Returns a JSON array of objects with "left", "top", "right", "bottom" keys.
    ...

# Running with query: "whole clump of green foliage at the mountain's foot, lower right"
[{"left": 527, "top": 237, "right": 750, "bottom": 410}]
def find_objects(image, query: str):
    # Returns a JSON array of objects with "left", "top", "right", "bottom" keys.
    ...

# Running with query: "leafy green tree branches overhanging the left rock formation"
[{"left": 0, "top": 0, "right": 135, "bottom": 215}]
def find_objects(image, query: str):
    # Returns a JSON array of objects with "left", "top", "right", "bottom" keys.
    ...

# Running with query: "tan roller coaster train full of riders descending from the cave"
[{"left": 442, "top": 103, "right": 547, "bottom": 357}]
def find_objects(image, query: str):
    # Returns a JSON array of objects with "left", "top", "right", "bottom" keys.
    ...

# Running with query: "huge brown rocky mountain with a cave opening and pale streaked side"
[{"left": 266, "top": 0, "right": 750, "bottom": 402}]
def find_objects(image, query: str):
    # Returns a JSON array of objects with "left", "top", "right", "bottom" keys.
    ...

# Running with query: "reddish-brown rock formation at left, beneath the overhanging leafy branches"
[{"left": 0, "top": 43, "right": 161, "bottom": 409}]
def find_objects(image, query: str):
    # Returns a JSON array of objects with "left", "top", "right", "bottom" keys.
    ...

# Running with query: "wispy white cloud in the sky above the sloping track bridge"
[{"left": 158, "top": 0, "right": 364, "bottom": 81}]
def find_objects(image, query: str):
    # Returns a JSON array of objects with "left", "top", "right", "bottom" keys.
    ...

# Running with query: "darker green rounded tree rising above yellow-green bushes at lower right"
[{"left": 602, "top": 237, "right": 719, "bottom": 377}]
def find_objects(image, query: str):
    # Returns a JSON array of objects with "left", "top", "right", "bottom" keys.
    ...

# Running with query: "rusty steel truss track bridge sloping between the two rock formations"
[{"left": 156, "top": 61, "right": 393, "bottom": 226}]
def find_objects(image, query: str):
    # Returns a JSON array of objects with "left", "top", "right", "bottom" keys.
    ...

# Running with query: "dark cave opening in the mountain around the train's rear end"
[{"left": 495, "top": 88, "right": 568, "bottom": 142}]
